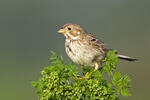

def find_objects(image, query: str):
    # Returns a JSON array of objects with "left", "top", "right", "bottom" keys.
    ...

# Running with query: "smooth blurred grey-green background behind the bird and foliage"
[{"left": 0, "top": 0, "right": 150, "bottom": 100}]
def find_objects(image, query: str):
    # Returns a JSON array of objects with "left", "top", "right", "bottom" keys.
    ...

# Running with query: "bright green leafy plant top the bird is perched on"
[{"left": 33, "top": 51, "right": 131, "bottom": 100}]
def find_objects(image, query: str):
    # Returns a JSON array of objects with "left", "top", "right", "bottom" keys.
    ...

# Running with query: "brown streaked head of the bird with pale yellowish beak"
[{"left": 58, "top": 23, "right": 85, "bottom": 40}]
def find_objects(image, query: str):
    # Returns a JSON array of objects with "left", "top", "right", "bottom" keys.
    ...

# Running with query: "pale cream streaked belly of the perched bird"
[{"left": 66, "top": 42, "right": 95, "bottom": 66}]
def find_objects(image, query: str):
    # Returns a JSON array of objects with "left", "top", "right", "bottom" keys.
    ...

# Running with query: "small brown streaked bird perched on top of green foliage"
[{"left": 58, "top": 23, "right": 137, "bottom": 70}]
